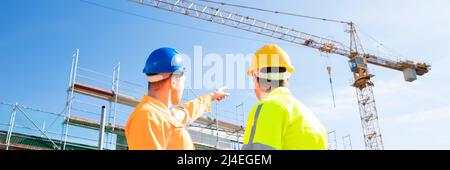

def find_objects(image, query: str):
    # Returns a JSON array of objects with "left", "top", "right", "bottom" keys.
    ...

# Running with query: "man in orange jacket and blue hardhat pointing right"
[{"left": 125, "top": 48, "right": 229, "bottom": 150}]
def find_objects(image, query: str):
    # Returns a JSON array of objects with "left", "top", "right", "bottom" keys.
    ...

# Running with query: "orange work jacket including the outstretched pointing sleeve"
[{"left": 125, "top": 95, "right": 211, "bottom": 150}]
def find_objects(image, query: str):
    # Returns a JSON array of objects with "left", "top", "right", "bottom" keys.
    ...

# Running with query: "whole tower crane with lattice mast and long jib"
[{"left": 128, "top": 0, "right": 431, "bottom": 150}]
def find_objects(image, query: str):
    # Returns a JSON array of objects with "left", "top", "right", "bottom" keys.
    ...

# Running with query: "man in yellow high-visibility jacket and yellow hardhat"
[{"left": 242, "top": 45, "right": 327, "bottom": 150}]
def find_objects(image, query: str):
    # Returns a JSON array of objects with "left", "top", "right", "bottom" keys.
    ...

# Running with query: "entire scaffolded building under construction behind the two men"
[{"left": 0, "top": 50, "right": 244, "bottom": 150}]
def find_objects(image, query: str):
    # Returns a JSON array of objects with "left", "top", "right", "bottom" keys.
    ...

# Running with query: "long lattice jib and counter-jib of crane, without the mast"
[{"left": 128, "top": 0, "right": 430, "bottom": 76}]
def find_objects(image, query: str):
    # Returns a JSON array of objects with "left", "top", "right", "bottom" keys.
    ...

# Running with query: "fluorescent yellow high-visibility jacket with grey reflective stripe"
[{"left": 242, "top": 87, "right": 327, "bottom": 150}]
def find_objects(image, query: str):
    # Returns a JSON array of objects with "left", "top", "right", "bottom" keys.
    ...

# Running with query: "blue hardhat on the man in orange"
[{"left": 143, "top": 47, "right": 185, "bottom": 74}]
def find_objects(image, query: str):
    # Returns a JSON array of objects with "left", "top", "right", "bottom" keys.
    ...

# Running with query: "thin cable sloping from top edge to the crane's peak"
[{"left": 199, "top": 0, "right": 351, "bottom": 24}]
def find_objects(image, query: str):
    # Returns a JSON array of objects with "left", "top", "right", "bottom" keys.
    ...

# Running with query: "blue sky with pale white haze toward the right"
[{"left": 0, "top": 0, "right": 450, "bottom": 149}]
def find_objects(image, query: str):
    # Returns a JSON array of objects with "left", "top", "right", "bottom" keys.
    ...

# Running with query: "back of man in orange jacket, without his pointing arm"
[{"left": 125, "top": 96, "right": 194, "bottom": 150}]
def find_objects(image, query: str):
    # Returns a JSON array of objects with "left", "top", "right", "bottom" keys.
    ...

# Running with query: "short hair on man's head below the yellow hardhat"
[{"left": 256, "top": 67, "right": 287, "bottom": 91}]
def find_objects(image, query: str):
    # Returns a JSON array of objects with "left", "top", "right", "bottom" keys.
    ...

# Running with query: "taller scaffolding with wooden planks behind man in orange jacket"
[{"left": 62, "top": 49, "right": 244, "bottom": 149}]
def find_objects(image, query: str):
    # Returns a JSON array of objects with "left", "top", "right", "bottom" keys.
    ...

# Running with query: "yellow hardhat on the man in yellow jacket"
[{"left": 247, "top": 44, "right": 294, "bottom": 76}]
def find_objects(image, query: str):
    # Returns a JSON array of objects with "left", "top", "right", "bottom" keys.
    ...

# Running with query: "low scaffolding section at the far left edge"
[{"left": 0, "top": 102, "right": 95, "bottom": 150}]
